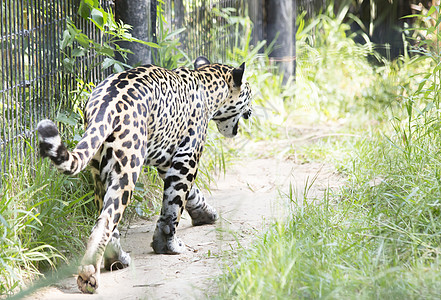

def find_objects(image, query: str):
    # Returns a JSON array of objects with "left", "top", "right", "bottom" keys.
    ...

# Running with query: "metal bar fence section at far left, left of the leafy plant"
[{"left": 0, "top": 0, "right": 112, "bottom": 177}]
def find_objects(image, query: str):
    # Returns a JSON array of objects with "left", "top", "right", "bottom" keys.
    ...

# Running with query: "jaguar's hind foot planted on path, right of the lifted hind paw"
[{"left": 104, "top": 228, "right": 131, "bottom": 271}]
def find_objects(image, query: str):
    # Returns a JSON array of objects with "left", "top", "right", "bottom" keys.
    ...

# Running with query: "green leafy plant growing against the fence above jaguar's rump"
[{"left": 57, "top": 0, "right": 160, "bottom": 135}]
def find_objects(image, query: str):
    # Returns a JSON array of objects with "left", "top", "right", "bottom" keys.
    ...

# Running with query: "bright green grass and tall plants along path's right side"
[{"left": 219, "top": 2, "right": 441, "bottom": 299}]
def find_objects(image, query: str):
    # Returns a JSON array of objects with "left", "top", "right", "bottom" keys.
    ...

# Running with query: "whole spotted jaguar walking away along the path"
[{"left": 37, "top": 57, "right": 251, "bottom": 293}]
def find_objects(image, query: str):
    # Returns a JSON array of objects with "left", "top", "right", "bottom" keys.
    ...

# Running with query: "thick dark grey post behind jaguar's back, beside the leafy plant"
[{"left": 115, "top": 0, "right": 152, "bottom": 66}]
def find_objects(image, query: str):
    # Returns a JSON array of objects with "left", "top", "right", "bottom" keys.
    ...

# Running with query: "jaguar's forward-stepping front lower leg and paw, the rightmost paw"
[{"left": 185, "top": 185, "right": 219, "bottom": 226}]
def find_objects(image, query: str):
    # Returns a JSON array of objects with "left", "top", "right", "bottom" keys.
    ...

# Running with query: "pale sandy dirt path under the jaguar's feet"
[{"left": 25, "top": 145, "right": 341, "bottom": 300}]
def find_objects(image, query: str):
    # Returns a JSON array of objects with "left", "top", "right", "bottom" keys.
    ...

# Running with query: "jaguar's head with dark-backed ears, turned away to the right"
[{"left": 195, "top": 57, "right": 252, "bottom": 137}]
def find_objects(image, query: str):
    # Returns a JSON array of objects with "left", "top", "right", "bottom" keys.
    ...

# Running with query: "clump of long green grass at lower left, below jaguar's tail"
[{"left": 0, "top": 157, "right": 93, "bottom": 294}]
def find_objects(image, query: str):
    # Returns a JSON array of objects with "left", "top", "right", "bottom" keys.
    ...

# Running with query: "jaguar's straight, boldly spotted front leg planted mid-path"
[{"left": 151, "top": 156, "right": 196, "bottom": 254}]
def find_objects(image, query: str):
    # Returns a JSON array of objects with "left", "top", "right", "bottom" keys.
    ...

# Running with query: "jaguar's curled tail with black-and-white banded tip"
[{"left": 37, "top": 120, "right": 109, "bottom": 175}]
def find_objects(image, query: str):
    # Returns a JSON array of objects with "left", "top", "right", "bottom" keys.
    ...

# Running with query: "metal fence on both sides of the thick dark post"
[{"left": 0, "top": 0, "right": 244, "bottom": 183}]
